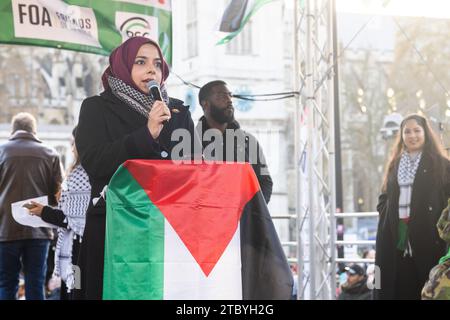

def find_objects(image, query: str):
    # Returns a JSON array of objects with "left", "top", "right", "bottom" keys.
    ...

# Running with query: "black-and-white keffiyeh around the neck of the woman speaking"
[{"left": 108, "top": 76, "right": 169, "bottom": 119}]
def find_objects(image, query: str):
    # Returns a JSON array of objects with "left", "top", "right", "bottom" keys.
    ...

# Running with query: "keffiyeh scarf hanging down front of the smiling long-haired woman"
[{"left": 397, "top": 152, "right": 422, "bottom": 257}]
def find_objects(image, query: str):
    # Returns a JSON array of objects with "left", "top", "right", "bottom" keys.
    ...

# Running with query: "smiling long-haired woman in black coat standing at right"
[{"left": 374, "top": 114, "right": 450, "bottom": 300}]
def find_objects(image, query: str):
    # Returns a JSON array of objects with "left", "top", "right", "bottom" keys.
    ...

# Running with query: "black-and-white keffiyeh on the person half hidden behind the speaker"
[{"left": 53, "top": 165, "right": 91, "bottom": 292}]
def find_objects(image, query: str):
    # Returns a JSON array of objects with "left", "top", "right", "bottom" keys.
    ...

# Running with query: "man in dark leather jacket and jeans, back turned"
[{"left": 0, "top": 113, "right": 62, "bottom": 300}]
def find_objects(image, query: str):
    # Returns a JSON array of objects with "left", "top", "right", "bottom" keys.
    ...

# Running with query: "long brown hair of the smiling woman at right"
[{"left": 382, "top": 113, "right": 448, "bottom": 192}]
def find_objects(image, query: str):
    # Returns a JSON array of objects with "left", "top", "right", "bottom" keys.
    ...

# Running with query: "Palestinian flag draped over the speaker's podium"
[{"left": 103, "top": 160, "right": 292, "bottom": 300}]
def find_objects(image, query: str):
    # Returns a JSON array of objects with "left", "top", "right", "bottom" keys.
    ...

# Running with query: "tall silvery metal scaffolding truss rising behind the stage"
[{"left": 294, "top": 0, "right": 336, "bottom": 300}]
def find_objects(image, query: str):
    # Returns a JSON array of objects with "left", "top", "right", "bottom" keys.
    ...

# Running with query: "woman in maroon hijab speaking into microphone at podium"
[{"left": 75, "top": 37, "right": 195, "bottom": 299}]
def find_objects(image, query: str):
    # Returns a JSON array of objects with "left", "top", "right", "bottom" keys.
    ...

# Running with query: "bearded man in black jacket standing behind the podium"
[{"left": 197, "top": 80, "right": 273, "bottom": 203}]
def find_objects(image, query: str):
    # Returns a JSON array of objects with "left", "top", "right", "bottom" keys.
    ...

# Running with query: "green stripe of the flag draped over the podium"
[{"left": 103, "top": 166, "right": 165, "bottom": 300}]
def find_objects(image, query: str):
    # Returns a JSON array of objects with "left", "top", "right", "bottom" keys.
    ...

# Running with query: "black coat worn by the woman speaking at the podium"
[{"left": 75, "top": 90, "right": 195, "bottom": 299}]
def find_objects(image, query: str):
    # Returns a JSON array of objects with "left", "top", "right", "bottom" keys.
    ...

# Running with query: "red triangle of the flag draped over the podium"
[{"left": 124, "top": 160, "right": 260, "bottom": 276}]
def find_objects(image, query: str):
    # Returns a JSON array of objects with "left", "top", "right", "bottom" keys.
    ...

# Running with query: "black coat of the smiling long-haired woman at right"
[{"left": 374, "top": 154, "right": 450, "bottom": 300}]
